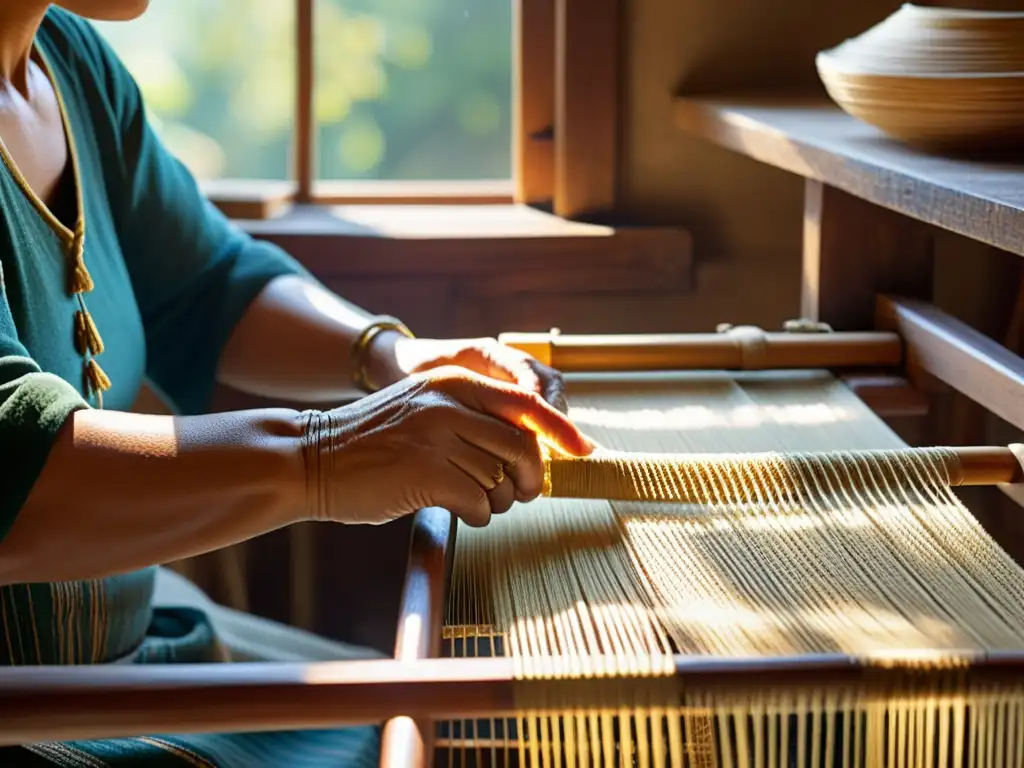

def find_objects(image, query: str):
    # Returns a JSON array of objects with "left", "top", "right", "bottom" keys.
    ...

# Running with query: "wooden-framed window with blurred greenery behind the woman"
[{"left": 98, "top": 0, "right": 617, "bottom": 219}]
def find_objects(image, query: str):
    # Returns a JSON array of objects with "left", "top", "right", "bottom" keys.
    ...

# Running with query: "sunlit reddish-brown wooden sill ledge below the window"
[{"left": 238, "top": 205, "right": 692, "bottom": 294}]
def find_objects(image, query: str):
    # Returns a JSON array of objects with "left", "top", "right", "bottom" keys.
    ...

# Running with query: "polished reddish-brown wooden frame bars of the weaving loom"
[{"left": 6, "top": 290, "right": 1024, "bottom": 768}]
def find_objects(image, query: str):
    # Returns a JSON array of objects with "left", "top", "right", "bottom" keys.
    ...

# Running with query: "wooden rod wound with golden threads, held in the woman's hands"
[{"left": 544, "top": 446, "right": 1024, "bottom": 504}]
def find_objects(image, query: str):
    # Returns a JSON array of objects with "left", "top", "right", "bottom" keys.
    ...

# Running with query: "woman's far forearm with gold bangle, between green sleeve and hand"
[{"left": 218, "top": 276, "right": 400, "bottom": 402}]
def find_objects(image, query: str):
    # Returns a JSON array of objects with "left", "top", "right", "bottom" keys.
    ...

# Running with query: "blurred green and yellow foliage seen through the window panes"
[{"left": 97, "top": 0, "right": 512, "bottom": 179}]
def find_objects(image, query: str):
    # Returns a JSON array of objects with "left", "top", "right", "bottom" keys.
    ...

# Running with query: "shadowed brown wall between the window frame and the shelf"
[{"left": 618, "top": 0, "right": 1024, "bottom": 333}]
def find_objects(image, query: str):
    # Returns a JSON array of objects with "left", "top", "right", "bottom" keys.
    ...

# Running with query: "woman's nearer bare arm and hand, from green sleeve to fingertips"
[{"left": 0, "top": 369, "right": 594, "bottom": 585}]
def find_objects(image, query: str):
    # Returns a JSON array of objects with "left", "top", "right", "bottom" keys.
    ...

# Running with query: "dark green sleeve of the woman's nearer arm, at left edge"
[{"left": 0, "top": 269, "right": 88, "bottom": 541}]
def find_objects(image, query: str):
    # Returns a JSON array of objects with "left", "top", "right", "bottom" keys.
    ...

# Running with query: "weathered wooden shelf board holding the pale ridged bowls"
[{"left": 675, "top": 97, "right": 1024, "bottom": 256}]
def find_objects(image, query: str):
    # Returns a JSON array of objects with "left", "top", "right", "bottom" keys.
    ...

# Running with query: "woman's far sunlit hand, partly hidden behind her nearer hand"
[{"left": 378, "top": 338, "right": 567, "bottom": 412}]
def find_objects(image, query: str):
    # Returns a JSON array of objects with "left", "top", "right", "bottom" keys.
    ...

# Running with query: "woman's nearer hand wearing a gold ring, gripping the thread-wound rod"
[{"left": 303, "top": 368, "right": 594, "bottom": 526}]
